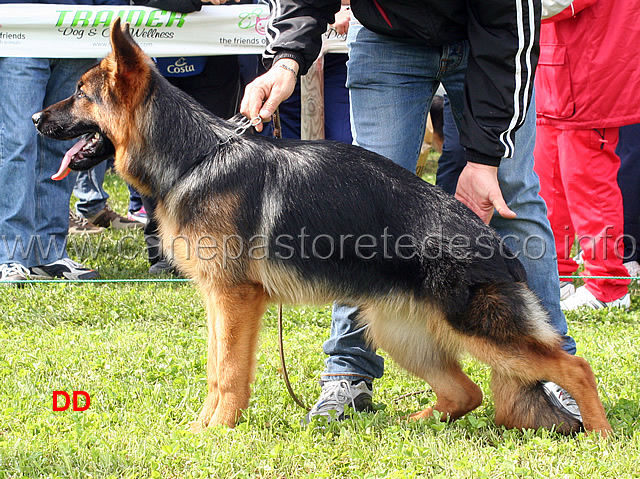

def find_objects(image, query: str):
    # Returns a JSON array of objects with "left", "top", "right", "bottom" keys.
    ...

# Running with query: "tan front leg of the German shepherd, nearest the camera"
[{"left": 200, "top": 284, "right": 267, "bottom": 427}]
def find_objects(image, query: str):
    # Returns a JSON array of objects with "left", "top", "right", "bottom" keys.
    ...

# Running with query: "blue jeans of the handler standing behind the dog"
[{"left": 322, "top": 23, "right": 575, "bottom": 379}]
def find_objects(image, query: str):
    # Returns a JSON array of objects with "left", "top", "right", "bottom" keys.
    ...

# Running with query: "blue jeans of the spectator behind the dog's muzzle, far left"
[{"left": 0, "top": 58, "right": 95, "bottom": 267}]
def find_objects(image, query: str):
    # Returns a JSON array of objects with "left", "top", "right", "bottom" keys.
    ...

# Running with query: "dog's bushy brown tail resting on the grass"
[{"left": 491, "top": 369, "right": 583, "bottom": 434}]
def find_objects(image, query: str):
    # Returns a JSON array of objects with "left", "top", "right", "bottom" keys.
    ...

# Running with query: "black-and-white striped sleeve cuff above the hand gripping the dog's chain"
[{"left": 263, "top": 0, "right": 340, "bottom": 75}]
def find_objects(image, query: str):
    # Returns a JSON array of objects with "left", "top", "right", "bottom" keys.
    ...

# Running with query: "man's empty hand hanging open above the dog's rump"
[{"left": 456, "top": 160, "right": 516, "bottom": 224}]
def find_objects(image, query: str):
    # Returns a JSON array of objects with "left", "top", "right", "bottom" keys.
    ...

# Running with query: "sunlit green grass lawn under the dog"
[{"left": 0, "top": 170, "right": 640, "bottom": 478}]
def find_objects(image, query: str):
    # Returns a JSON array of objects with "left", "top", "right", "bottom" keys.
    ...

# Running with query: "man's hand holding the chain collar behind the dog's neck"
[{"left": 240, "top": 58, "right": 299, "bottom": 131}]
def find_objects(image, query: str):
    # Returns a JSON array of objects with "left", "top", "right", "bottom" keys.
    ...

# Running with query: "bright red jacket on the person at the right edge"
[{"left": 535, "top": 0, "right": 640, "bottom": 129}]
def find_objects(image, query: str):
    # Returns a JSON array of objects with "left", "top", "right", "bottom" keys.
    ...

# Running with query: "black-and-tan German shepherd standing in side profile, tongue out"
[{"left": 33, "top": 19, "right": 611, "bottom": 434}]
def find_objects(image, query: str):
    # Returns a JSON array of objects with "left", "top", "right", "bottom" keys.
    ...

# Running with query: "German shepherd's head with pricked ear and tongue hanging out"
[{"left": 32, "top": 18, "right": 152, "bottom": 180}]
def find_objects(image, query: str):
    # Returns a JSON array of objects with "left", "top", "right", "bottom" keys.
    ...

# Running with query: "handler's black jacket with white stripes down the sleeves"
[{"left": 264, "top": 0, "right": 541, "bottom": 166}]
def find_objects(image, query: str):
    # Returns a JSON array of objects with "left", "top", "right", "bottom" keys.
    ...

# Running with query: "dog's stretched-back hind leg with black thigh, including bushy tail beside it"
[{"left": 460, "top": 283, "right": 611, "bottom": 435}]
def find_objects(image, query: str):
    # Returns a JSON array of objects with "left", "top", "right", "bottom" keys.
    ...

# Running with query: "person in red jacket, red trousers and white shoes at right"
[{"left": 534, "top": 0, "right": 640, "bottom": 310}]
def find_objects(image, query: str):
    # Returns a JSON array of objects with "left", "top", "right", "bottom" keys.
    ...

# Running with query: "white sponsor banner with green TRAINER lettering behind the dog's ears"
[{"left": 0, "top": 3, "right": 347, "bottom": 58}]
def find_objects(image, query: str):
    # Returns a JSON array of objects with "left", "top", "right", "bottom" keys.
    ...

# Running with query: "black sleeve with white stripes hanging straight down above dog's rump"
[{"left": 460, "top": 0, "right": 541, "bottom": 166}]
